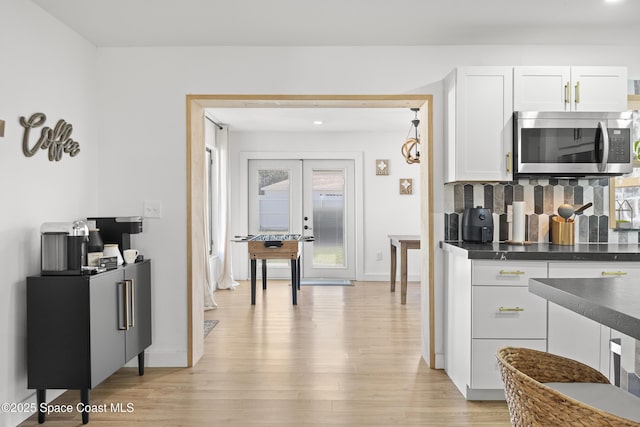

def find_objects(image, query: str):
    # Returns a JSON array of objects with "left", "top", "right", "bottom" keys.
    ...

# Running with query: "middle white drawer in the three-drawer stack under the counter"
[{"left": 471, "top": 286, "right": 547, "bottom": 339}]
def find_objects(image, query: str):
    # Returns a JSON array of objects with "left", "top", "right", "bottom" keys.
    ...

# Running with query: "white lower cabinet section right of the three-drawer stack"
[{"left": 548, "top": 261, "right": 640, "bottom": 378}]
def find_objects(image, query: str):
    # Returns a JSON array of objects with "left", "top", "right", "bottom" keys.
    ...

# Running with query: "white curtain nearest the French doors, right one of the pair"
[{"left": 216, "top": 126, "right": 238, "bottom": 289}]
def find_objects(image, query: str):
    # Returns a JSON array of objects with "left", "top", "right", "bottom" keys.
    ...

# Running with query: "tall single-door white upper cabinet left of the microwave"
[{"left": 444, "top": 67, "right": 513, "bottom": 182}]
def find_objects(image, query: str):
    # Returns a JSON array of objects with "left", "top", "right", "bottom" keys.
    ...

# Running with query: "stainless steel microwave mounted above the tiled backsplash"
[{"left": 513, "top": 111, "right": 634, "bottom": 177}]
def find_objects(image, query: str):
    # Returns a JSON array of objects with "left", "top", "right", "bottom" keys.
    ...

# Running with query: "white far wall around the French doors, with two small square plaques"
[{"left": 231, "top": 132, "right": 420, "bottom": 281}]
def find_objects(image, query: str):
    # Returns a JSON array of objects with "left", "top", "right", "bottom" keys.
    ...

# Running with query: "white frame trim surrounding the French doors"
[{"left": 236, "top": 151, "right": 364, "bottom": 280}]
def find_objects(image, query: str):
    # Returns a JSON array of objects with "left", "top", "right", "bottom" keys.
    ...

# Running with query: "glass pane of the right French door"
[{"left": 312, "top": 170, "right": 345, "bottom": 268}]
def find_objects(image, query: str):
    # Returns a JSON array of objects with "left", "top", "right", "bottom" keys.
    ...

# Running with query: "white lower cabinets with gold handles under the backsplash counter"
[{"left": 444, "top": 251, "right": 640, "bottom": 400}]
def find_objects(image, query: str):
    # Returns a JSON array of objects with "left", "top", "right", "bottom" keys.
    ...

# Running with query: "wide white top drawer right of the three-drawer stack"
[{"left": 549, "top": 261, "right": 640, "bottom": 278}]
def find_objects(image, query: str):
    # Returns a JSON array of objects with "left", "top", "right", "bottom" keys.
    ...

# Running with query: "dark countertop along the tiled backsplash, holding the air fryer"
[{"left": 440, "top": 241, "right": 640, "bottom": 261}]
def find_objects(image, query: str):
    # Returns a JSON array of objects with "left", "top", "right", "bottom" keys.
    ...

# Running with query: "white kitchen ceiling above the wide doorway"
[{"left": 32, "top": 0, "right": 640, "bottom": 46}]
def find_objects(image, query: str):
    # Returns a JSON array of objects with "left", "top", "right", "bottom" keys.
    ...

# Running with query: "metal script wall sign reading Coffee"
[{"left": 20, "top": 113, "right": 80, "bottom": 162}]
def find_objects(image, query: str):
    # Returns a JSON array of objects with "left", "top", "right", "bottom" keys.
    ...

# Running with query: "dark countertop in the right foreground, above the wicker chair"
[{"left": 529, "top": 278, "right": 640, "bottom": 340}]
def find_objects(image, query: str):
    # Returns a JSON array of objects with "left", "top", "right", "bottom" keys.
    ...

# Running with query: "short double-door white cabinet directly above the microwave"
[{"left": 513, "top": 67, "right": 627, "bottom": 111}]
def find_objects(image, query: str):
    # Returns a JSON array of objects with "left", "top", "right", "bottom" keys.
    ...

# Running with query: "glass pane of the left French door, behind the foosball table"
[{"left": 257, "top": 169, "right": 291, "bottom": 266}]
